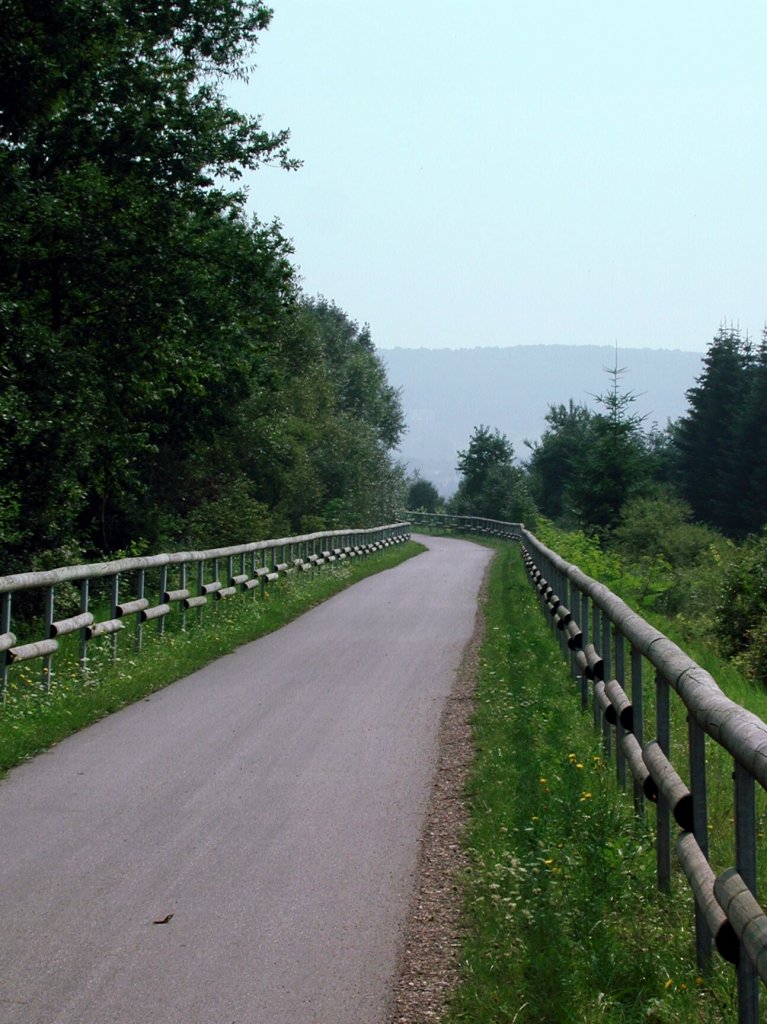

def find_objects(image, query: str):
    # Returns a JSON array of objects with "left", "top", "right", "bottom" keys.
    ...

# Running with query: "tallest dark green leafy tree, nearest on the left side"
[{"left": 0, "top": 0, "right": 292, "bottom": 561}]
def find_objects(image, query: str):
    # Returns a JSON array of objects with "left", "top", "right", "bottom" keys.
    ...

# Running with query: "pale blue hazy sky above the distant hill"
[{"left": 232, "top": 0, "right": 767, "bottom": 351}]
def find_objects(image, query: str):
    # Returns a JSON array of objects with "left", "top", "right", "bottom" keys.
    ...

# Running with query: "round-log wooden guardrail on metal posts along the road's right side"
[{"left": 412, "top": 513, "right": 767, "bottom": 1024}]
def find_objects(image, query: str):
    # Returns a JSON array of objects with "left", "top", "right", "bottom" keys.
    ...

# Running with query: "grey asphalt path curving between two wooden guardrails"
[{"left": 0, "top": 538, "right": 489, "bottom": 1024}]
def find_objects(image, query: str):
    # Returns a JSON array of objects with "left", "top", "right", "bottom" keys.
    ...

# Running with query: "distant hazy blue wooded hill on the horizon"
[{"left": 379, "top": 345, "right": 704, "bottom": 497}]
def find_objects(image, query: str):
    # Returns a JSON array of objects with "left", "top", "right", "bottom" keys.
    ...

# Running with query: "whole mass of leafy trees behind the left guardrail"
[{"left": 0, "top": 0, "right": 403, "bottom": 572}]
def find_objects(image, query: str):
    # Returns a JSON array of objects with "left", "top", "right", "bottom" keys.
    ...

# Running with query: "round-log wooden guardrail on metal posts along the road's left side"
[{"left": 0, "top": 522, "right": 410, "bottom": 698}]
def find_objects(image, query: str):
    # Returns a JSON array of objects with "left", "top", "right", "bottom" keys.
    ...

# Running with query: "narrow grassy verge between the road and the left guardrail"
[{"left": 0, "top": 542, "right": 424, "bottom": 773}]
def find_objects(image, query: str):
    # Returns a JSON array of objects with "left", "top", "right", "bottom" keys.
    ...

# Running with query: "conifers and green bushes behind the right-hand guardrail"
[{"left": 409, "top": 326, "right": 767, "bottom": 707}]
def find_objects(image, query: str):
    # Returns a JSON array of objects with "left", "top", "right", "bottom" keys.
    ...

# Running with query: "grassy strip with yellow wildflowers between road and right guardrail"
[{"left": 446, "top": 544, "right": 735, "bottom": 1024}]
